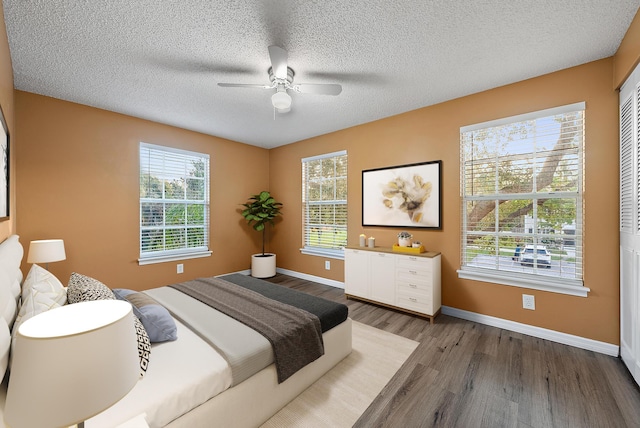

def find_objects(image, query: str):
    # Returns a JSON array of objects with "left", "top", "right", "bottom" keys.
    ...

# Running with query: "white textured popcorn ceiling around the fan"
[{"left": 3, "top": 0, "right": 640, "bottom": 148}]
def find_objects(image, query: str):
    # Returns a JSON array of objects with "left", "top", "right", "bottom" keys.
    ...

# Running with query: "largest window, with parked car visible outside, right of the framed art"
[{"left": 458, "top": 103, "right": 589, "bottom": 296}]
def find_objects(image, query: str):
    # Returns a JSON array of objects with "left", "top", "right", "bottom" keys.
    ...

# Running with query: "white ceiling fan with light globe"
[{"left": 218, "top": 45, "right": 342, "bottom": 113}]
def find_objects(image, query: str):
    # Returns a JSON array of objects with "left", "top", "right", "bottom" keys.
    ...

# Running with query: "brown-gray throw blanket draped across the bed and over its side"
[{"left": 170, "top": 278, "right": 324, "bottom": 383}]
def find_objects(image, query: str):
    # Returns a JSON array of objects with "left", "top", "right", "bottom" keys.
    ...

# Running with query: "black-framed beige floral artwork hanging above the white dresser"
[{"left": 362, "top": 160, "right": 442, "bottom": 229}]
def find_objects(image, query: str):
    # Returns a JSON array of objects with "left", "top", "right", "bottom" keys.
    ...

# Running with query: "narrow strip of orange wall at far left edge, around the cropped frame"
[{"left": 0, "top": 2, "right": 16, "bottom": 242}]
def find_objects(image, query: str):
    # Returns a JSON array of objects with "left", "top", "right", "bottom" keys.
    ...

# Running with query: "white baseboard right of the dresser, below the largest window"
[{"left": 442, "top": 306, "right": 620, "bottom": 357}]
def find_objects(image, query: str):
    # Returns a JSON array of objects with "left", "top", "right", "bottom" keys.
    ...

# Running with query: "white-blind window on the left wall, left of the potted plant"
[{"left": 138, "top": 143, "right": 211, "bottom": 264}]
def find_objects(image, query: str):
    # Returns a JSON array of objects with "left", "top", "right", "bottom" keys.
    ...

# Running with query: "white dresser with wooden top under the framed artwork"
[{"left": 344, "top": 247, "right": 441, "bottom": 324}]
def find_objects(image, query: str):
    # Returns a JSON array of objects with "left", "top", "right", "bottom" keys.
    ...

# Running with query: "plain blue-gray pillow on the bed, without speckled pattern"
[{"left": 113, "top": 288, "right": 178, "bottom": 343}]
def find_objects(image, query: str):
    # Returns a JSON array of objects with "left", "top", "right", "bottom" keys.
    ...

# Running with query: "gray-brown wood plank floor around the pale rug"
[{"left": 269, "top": 274, "right": 640, "bottom": 428}]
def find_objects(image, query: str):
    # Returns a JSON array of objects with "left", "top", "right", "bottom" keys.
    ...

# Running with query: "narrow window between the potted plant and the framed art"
[{"left": 301, "top": 151, "right": 347, "bottom": 259}]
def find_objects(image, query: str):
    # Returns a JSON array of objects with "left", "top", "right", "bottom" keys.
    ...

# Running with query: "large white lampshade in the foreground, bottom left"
[{"left": 4, "top": 300, "right": 140, "bottom": 428}]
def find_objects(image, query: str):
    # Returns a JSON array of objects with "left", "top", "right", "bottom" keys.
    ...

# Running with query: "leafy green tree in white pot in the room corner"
[{"left": 242, "top": 190, "right": 282, "bottom": 278}]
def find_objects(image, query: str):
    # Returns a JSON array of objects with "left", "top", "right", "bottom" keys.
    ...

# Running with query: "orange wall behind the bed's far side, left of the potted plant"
[{"left": 15, "top": 91, "right": 269, "bottom": 290}]
